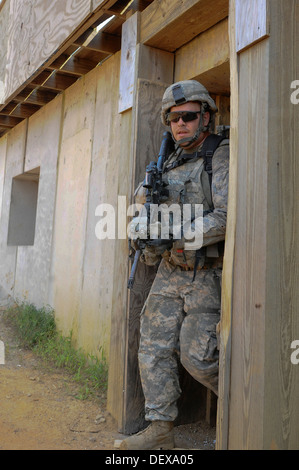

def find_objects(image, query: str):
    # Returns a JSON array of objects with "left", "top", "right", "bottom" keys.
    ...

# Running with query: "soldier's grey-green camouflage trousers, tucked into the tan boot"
[{"left": 138, "top": 260, "right": 221, "bottom": 421}]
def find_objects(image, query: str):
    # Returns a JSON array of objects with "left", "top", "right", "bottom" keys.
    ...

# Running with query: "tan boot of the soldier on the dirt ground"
[{"left": 120, "top": 421, "right": 174, "bottom": 450}]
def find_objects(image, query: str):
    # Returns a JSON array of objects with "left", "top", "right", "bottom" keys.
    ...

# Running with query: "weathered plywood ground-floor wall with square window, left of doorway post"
[{"left": 0, "top": 50, "right": 131, "bottom": 356}]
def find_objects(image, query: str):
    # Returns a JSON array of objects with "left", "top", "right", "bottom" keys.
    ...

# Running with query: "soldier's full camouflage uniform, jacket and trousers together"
[{"left": 138, "top": 140, "right": 229, "bottom": 421}]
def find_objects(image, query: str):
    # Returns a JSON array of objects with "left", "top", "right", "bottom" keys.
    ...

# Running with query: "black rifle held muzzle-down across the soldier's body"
[{"left": 128, "top": 131, "right": 174, "bottom": 289}]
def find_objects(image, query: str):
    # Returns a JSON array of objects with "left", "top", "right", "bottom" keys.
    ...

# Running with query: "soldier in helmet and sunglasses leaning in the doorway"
[{"left": 120, "top": 80, "right": 229, "bottom": 450}]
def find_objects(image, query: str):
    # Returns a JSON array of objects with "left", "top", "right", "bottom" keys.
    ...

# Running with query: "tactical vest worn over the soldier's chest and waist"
[{"left": 161, "top": 134, "right": 228, "bottom": 269}]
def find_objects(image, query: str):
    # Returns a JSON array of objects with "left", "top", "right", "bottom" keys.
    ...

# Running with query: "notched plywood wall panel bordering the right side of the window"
[{"left": 15, "top": 96, "right": 62, "bottom": 307}]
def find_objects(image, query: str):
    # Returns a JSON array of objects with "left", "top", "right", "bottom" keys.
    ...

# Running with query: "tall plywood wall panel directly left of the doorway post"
[{"left": 79, "top": 53, "right": 123, "bottom": 360}]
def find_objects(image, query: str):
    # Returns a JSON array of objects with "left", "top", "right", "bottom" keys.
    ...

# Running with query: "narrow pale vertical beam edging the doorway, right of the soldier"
[{"left": 216, "top": 0, "right": 239, "bottom": 450}]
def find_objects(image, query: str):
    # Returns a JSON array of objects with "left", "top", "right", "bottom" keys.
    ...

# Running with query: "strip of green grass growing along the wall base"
[{"left": 6, "top": 303, "right": 108, "bottom": 399}]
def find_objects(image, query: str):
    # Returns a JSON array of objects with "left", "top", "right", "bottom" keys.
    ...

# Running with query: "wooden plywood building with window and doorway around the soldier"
[{"left": 0, "top": 0, "right": 299, "bottom": 449}]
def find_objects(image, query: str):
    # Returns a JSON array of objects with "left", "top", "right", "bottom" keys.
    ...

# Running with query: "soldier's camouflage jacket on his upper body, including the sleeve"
[{"left": 137, "top": 139, "right": 229, "bottom": 268}]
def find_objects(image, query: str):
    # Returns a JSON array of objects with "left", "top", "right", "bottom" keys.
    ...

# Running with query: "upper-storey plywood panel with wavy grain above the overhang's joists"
[{"left": 0, "top": 0, "right": 91, "bottom": 100}]
